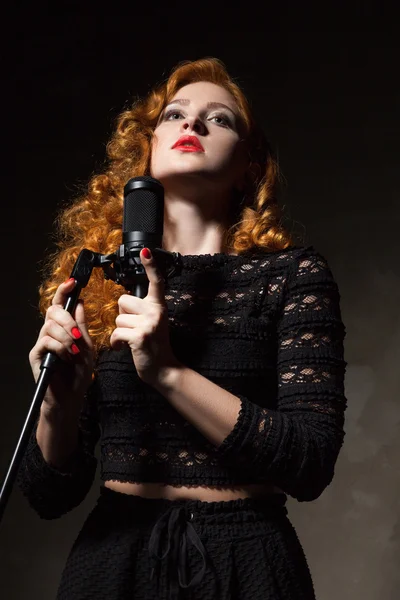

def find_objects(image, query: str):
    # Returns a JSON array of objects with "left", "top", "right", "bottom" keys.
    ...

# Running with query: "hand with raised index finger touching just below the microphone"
[{"left": 110, "top": 247, "right": 183, "bottom": 385}]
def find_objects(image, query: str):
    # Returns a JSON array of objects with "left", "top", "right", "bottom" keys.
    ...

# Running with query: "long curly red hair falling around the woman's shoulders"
[{"left": 39, "top": 58, "right": 293, "bottom": 352}]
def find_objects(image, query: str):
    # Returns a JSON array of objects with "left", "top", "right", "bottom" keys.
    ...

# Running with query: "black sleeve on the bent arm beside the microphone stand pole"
[{"left": 17, "top": 382, "right": 100, "bottom": 519}]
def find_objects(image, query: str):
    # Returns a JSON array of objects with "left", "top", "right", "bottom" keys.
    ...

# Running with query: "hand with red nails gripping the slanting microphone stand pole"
[{"left": 29, "top": 278, "right": 94, "bottom": 414}]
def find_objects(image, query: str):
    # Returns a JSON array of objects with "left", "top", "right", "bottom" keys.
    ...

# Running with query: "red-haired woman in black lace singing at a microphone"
[{"left": 19, "top": 59, "right": 346, "bottom": 600}]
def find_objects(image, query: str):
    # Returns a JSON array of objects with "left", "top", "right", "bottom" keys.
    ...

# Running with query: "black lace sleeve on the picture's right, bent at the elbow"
[{"left": 217, "top": 247, "right": 347, "bottom": 502}]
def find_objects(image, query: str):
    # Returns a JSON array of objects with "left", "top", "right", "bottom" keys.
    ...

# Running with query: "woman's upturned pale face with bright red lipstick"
[{"left": 150, "top": 81, "right": 247, "bottom": 192}]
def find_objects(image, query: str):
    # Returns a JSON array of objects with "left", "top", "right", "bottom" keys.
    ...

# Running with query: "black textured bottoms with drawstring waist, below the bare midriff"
[{"left": 57, "top": 487, "right": 315, "bottom": 600}]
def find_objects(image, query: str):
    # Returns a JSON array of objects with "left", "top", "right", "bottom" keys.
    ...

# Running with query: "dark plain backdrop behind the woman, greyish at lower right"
[{"left": 0, "top": 2, "right": 400, "bottom": 600}]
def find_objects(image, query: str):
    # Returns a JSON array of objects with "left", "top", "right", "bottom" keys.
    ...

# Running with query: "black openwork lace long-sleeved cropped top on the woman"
[{"left": 18, "top": 246, "right": 347, "bottom": 519}]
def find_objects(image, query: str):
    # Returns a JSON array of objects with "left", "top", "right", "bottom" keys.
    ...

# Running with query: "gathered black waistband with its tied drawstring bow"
[{"left": 98, "top": 486, "right": 288, "bottom": 592}]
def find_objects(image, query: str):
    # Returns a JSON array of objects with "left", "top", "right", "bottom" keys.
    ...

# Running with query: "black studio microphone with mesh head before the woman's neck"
[{"left": 118, "top": 176, "right": 164, "bottom": 298}]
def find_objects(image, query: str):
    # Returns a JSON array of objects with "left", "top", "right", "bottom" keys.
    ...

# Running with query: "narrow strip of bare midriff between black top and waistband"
[{"left": 104, "top": 480, "right": 284, "bottom": 502}]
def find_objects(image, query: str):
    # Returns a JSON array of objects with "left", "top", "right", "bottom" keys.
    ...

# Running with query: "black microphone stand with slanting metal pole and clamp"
[{"left": 0, "top": 244, "right": 182, "bottom": 522}]
